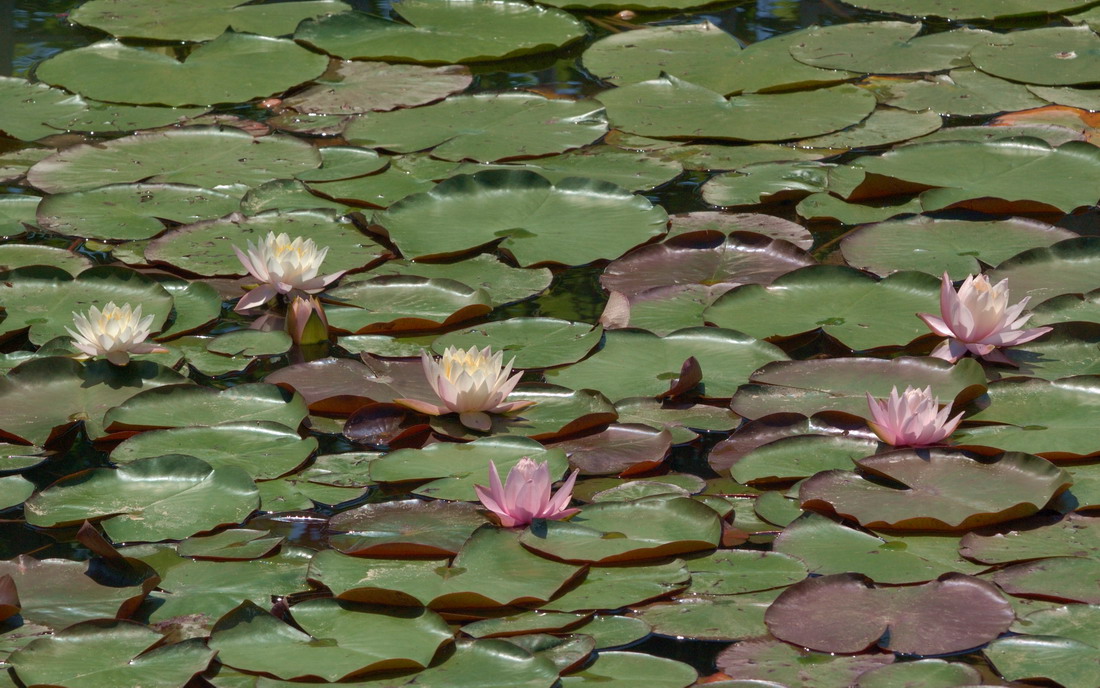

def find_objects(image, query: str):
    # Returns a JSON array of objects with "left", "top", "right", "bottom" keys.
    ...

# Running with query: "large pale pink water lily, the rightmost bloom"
[{"left": 916, "top": 272, "right": 1052, "bottom": 365}]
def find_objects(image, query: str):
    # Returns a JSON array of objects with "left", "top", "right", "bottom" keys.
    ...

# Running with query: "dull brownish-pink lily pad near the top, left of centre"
[{"left": 283, "top": 61, "right": 473, "bottom": 114}]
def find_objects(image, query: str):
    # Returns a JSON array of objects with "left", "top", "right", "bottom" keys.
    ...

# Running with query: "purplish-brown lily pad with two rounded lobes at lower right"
[{"left": 765, "top": 574, "right": 1015, "bottom": 655}]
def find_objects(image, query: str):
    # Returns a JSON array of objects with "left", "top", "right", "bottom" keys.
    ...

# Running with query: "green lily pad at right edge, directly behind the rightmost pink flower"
[{"left": 989, "top": 237, "right": 1100, "bottom": 304}]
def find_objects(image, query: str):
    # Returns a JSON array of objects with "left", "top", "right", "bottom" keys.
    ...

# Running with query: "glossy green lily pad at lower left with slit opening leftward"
[{"left": 24, "top": 455, "right": 260, "bottom": 542}]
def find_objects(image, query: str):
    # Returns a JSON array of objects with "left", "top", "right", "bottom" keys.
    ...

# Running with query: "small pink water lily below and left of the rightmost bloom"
[{"left": 867, "top": 386, "right": 963, "bottom": 447}]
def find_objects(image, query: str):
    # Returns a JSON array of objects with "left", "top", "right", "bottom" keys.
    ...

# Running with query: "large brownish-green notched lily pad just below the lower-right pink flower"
[{"left": 799, "top": 449, "right": 1071, "bottom": 531}]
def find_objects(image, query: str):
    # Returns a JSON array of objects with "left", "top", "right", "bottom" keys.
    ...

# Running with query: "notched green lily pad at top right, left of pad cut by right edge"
[{"left": 791, "top": 22, "right": 1000, "bottom": 74}]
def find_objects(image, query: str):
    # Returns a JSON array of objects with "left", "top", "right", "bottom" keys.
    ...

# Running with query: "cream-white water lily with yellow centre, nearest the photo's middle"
[{"left": 394, "top": 347, "right": 535, "bottom": 433}]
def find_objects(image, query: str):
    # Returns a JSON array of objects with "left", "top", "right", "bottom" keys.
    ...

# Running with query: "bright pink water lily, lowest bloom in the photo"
[{"left": 474, "top": 457, "right": 581, "bottom": 528}]
